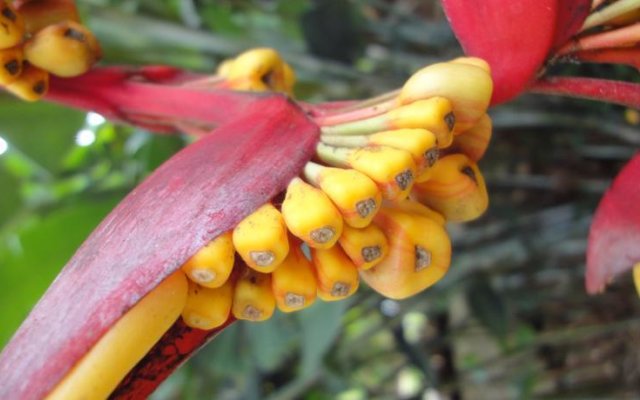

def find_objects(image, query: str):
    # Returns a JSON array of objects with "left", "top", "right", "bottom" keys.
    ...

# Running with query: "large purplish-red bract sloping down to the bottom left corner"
[{"left": 0, "top": 95, "right": 318, "bottom": 399}]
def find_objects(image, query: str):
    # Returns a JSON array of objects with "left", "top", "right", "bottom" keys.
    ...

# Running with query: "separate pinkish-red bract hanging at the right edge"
[{"left": 586, "top": 155, "right": 640, "bottom": 293}]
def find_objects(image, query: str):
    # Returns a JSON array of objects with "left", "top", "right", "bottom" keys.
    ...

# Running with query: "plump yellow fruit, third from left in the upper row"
[{"left": 282, "top": 178, "right": 343, "bottom": 249}]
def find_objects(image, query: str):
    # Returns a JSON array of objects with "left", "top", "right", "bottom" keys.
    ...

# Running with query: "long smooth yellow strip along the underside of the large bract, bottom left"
[{"left": 46, "top": 271, "right": 188, "bottom": 400}]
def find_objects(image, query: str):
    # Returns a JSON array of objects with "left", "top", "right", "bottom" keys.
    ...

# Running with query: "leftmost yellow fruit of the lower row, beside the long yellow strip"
[{"left": 182, "top": 280, "right": 233, "bottom": 330}]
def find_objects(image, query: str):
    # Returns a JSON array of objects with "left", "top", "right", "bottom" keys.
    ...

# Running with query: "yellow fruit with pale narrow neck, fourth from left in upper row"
[{"left": 304, "top": 162, "right": 382, "bottom": 228}]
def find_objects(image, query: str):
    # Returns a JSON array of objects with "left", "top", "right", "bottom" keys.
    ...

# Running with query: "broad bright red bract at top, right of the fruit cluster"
[{"left": 442, "top": 0, "right": 558, "bottom": 104}]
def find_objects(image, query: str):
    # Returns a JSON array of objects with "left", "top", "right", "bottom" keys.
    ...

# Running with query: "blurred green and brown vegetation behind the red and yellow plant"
[{"left": 0, "top": 0, "right": 640, "bottom": 400}]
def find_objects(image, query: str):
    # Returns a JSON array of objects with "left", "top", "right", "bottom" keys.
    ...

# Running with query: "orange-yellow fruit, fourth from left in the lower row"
[{"left": 311, "top": 246, "right": 360, "bottom": 301}]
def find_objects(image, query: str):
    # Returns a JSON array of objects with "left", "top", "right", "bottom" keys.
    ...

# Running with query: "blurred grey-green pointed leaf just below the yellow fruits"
[{"left": 295, "top": 300, "right": 351, "bottom": 376}]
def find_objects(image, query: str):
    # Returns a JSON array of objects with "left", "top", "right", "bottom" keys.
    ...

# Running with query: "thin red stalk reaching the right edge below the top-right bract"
[{"left": 531, "top": 77, "right": 640, "bottom": 109}]
